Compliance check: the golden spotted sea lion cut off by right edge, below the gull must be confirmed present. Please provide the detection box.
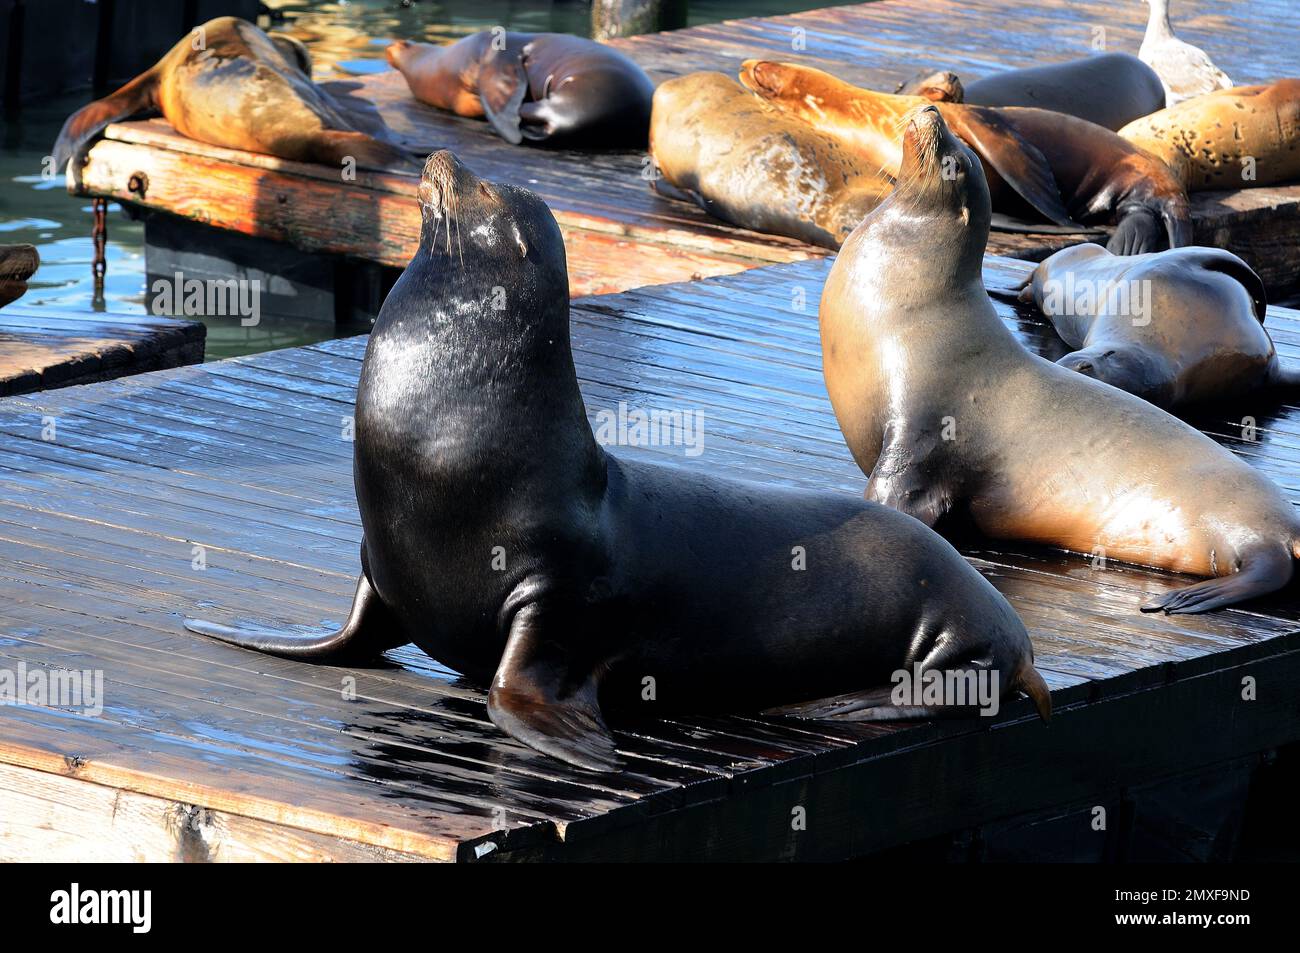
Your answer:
[1119,79,1300,192]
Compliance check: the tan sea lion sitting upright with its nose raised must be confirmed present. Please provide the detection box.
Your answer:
[820,104,1300,612]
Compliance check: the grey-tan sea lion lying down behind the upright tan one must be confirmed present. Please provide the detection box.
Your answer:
[1021,244,1300,408]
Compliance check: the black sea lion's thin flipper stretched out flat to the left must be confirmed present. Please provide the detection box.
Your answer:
[185,573,411,663]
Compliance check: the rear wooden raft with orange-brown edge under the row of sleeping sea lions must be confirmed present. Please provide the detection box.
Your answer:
[73,0,1300,295]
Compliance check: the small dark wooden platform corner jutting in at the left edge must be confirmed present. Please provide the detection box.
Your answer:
[0,302,207,395]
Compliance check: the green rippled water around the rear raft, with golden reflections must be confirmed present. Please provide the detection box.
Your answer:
[0,0,833,360]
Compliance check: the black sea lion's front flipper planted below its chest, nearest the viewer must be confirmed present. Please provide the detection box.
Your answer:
[488,603,619,771]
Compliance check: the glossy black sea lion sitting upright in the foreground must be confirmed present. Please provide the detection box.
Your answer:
[186,152,1050,770]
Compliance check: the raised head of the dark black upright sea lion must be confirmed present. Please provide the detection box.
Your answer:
[416,150,568,286]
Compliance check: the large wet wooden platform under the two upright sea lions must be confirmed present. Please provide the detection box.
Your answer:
[0,260,1300,861]
